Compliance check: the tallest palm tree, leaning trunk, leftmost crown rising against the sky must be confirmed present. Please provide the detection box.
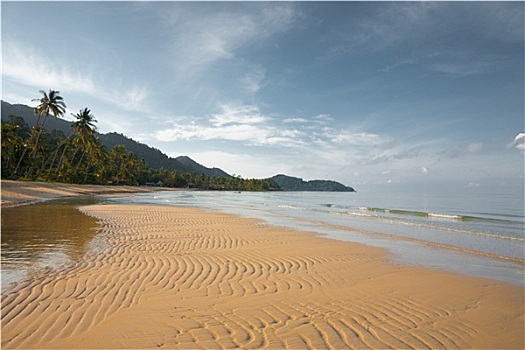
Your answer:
[15,90,66,177]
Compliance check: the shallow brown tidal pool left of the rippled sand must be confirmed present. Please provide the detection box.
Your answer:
[1,198,99,290]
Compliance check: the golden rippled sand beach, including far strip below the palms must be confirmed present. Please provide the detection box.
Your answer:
[2,181,525,349]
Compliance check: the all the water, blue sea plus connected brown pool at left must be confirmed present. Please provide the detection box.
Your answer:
[2,186,525,291]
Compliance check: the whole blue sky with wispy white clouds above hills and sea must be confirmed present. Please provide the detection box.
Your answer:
[1,1,525,189]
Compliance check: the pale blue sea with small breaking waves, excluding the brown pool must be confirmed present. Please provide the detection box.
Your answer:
[112,189,525,285]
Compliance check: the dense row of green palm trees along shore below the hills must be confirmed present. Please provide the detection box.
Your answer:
[1,90,279,191]
